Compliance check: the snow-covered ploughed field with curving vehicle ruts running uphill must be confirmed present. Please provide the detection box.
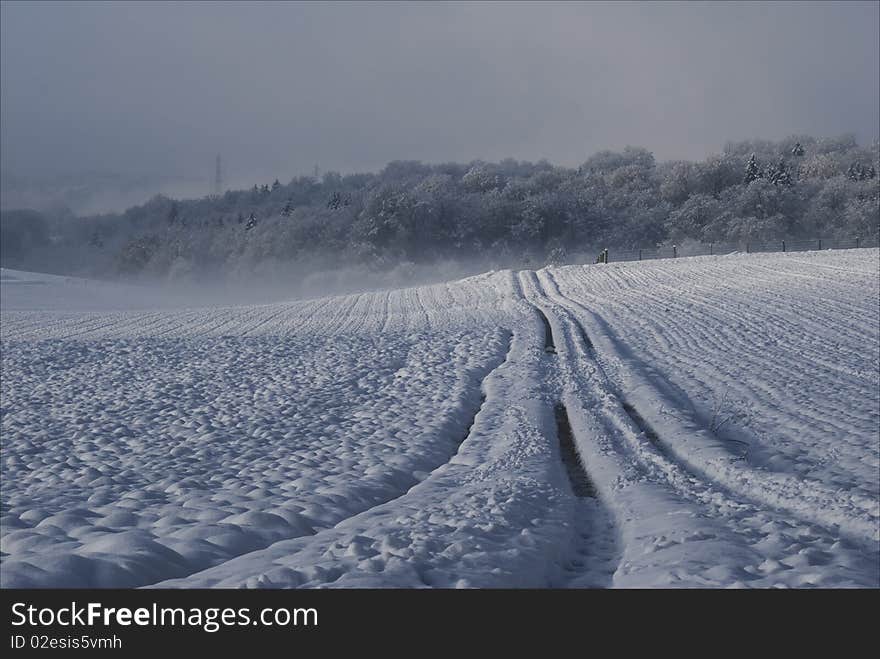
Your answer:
[0,249,880,587]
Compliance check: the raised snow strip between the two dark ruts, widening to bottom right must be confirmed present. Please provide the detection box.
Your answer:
[531,272,878,587]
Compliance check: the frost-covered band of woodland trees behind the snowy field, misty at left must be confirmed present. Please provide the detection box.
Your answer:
[0,135,880,278]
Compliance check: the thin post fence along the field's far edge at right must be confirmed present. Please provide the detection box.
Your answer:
[596,237,880,263]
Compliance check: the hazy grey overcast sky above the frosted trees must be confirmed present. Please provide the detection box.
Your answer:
[0,2,880,186]
